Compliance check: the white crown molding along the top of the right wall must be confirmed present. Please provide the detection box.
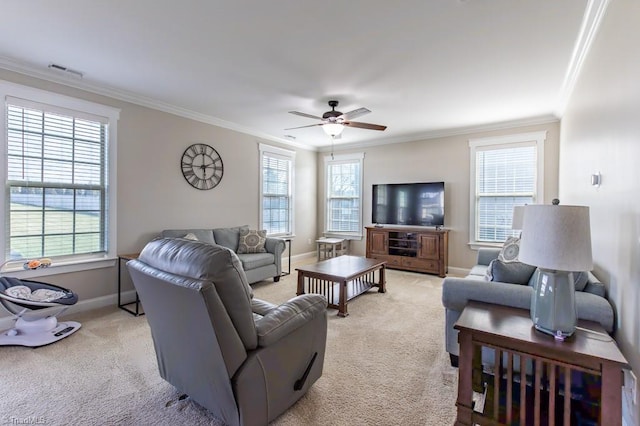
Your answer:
[555,0,610,117]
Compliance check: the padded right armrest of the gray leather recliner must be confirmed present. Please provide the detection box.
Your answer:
[256,294,327,347]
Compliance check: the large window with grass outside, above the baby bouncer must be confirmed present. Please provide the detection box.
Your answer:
[0,83,118,272]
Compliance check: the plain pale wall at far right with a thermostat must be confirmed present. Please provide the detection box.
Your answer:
[560,0,640,421]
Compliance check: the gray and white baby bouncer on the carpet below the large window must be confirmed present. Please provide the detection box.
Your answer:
[0,277,80,347]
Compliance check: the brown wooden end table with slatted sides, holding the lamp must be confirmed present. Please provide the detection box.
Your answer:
[455,302,628,426]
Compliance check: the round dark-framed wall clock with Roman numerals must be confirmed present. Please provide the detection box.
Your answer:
[182,143,224,190]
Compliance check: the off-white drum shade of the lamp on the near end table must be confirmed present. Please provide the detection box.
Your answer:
[518,204,593,271]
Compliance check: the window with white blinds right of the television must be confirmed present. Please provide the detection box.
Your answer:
[469,132,546,245]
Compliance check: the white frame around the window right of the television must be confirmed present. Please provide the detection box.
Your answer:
[469,131,547,250]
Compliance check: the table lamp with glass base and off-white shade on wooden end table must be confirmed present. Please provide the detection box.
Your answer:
[519,200,593,340]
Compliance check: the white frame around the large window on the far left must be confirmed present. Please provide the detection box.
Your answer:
[0,80,120,277]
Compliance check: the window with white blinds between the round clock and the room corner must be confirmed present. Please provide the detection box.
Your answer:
[259,144,295,236]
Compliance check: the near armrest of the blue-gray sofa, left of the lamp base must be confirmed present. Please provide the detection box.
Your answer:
[442,277,533,312]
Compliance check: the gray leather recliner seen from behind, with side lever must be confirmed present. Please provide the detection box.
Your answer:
[127,238,327,426]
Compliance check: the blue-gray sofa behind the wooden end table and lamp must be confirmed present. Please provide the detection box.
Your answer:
[442,248,614,366]
